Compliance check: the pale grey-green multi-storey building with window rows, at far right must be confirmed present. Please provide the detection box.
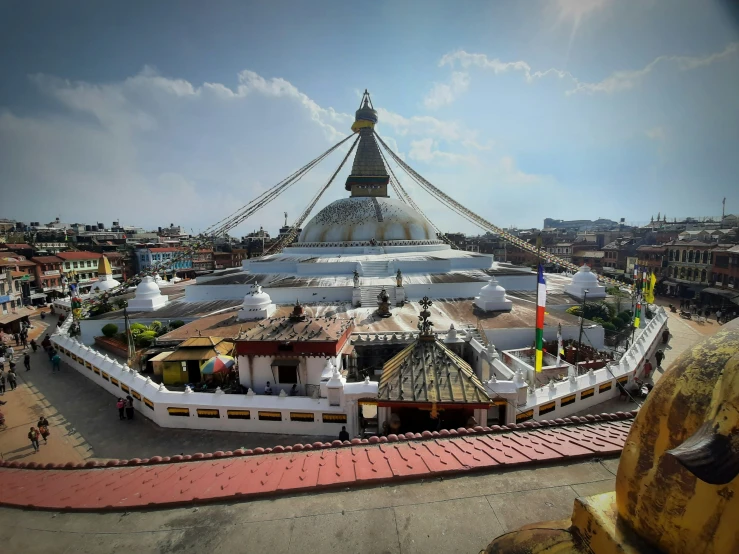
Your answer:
[664,240,714,296]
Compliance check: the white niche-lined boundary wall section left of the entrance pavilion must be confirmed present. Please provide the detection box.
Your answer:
[51,318,377,437]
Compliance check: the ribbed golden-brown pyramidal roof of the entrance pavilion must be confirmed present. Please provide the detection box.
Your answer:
[378,337,491,404]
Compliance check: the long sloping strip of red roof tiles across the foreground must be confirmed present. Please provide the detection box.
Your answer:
[0,413,634,511]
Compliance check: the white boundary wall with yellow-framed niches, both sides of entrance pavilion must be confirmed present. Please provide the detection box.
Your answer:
[51,307,667,436]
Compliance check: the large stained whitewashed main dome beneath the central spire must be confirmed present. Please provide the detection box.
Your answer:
[298,197,437,243]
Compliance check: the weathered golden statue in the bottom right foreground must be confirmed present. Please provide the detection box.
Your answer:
[484,320,739,554]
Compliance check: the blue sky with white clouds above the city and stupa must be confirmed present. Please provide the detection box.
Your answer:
[0,0,739,234]
